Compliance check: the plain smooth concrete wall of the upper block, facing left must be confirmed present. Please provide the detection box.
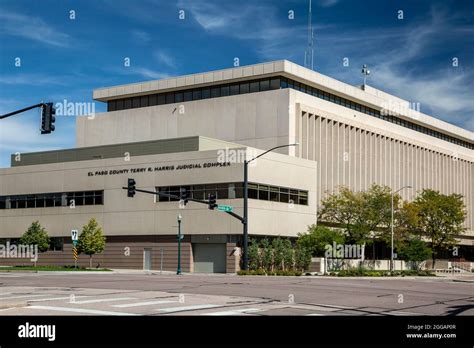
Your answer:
[76,89,289,153]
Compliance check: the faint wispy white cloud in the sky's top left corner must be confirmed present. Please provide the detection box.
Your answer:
[0,10,70,47]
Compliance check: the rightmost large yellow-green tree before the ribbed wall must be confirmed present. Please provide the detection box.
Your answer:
[413,189,466,268]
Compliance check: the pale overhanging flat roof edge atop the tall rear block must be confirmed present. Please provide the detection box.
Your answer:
[93,60,474,141]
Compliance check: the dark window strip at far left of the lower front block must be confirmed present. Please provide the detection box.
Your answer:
[0,191,104,209]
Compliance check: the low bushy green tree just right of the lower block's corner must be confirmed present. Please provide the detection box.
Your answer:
[296,225,344,257]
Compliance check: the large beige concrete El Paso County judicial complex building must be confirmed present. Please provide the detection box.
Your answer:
[0,60,474,272]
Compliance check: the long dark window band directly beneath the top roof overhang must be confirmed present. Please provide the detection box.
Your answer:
[107,77,474,149]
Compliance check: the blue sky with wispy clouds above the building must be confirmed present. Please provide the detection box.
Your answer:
[0,0,474,167]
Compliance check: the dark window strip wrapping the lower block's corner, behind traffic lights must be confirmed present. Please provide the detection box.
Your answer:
[156,182,308,205]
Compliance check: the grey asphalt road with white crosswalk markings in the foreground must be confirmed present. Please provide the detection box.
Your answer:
[0,272,474,315]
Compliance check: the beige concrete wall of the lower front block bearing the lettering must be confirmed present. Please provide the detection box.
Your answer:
[0,150,316,237]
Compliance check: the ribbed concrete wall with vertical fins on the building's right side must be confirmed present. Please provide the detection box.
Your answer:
[290,91,474,239]
